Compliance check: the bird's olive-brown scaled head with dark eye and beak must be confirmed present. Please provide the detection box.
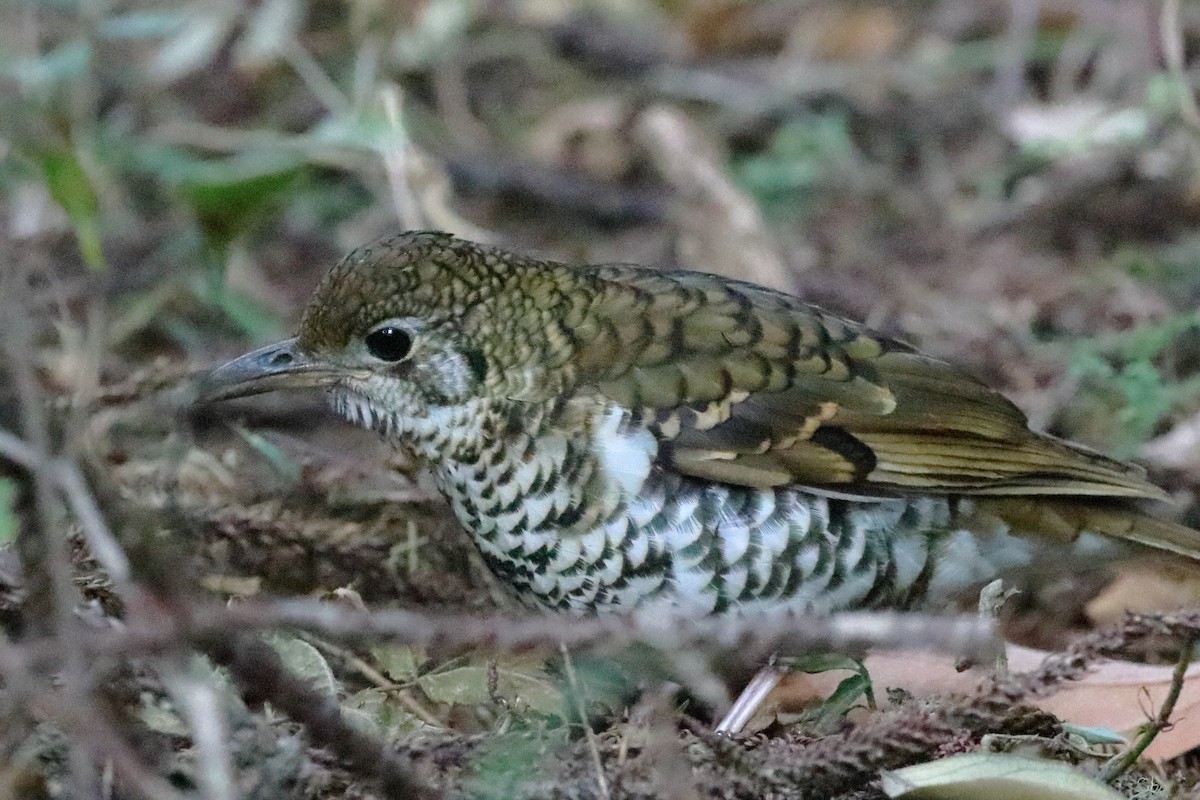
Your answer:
[198,233,577,450]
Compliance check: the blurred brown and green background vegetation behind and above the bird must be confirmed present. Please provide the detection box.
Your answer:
[7,0,1200,456]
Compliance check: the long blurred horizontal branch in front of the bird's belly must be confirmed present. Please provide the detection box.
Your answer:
[0,599,998,674]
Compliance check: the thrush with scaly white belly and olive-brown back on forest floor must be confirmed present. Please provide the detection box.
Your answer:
[197,231,1200,734]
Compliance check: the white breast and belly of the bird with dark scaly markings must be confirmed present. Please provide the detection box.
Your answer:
[438,402,984,613]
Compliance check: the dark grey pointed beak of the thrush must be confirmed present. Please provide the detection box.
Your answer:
[196,338,341,403]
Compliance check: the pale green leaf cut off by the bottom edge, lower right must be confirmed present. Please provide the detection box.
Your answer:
[882,753,1123,800]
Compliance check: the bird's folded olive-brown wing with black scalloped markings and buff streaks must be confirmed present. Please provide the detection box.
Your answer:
[563,265,1163,498]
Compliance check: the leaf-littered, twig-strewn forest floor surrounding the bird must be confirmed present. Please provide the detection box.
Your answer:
[7,0,1200,800]
